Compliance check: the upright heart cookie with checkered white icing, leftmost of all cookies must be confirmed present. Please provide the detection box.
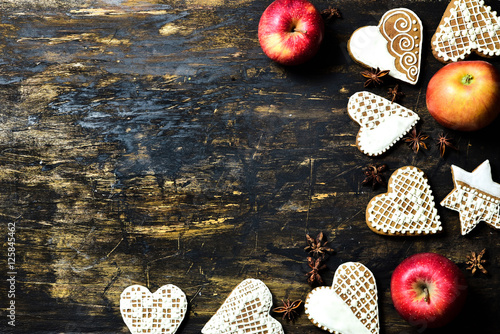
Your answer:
[120,284,187,334]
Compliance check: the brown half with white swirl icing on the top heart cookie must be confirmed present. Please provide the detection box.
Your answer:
[379,8,422,82]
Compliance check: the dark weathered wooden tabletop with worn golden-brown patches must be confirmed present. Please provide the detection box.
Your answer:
[0,0,500,334]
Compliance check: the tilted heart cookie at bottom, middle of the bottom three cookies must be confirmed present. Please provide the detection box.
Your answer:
[201,279,284,334]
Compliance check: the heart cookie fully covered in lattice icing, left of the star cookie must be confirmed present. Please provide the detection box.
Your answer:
[366,166,442,235]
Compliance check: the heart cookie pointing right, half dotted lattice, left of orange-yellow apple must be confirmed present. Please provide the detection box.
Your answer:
[347,91,419,156]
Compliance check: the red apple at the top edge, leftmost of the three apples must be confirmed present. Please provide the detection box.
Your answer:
[259,0,325,65]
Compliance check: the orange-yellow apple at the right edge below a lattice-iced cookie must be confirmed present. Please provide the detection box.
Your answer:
[426,60,500,131]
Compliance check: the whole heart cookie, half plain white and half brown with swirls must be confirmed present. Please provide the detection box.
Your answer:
[347,8,422,85]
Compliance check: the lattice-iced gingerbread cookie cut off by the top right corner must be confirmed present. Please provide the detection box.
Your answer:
[431,0,500,63]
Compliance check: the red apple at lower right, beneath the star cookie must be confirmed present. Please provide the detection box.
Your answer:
[391,253,467,329]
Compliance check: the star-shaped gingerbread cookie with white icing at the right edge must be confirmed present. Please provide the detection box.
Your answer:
[441,160,500,235]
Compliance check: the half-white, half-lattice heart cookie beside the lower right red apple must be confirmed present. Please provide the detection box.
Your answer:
[304,262,380,334]
